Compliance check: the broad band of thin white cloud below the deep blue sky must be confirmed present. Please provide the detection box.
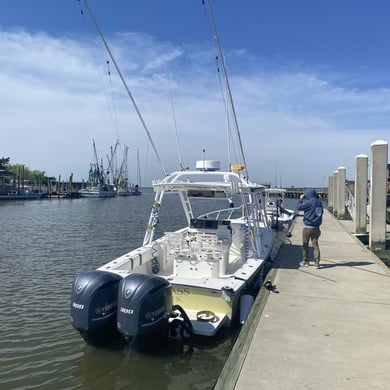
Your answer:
[0,31,390,186]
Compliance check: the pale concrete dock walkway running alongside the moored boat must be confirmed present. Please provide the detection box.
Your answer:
[214,210,390,390]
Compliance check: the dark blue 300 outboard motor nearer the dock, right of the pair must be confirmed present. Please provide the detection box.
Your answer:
[118,274,172,349]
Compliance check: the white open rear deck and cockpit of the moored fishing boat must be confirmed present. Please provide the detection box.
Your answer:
[99,227,265,289]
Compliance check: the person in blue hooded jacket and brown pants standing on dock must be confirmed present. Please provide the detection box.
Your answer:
[298,188,324,268]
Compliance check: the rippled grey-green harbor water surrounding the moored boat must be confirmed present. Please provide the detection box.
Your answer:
[0,190,296,390]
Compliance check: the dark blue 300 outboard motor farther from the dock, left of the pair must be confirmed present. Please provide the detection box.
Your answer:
[70,270,122,345]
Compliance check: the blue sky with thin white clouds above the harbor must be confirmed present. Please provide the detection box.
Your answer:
[0,0,390,187]
